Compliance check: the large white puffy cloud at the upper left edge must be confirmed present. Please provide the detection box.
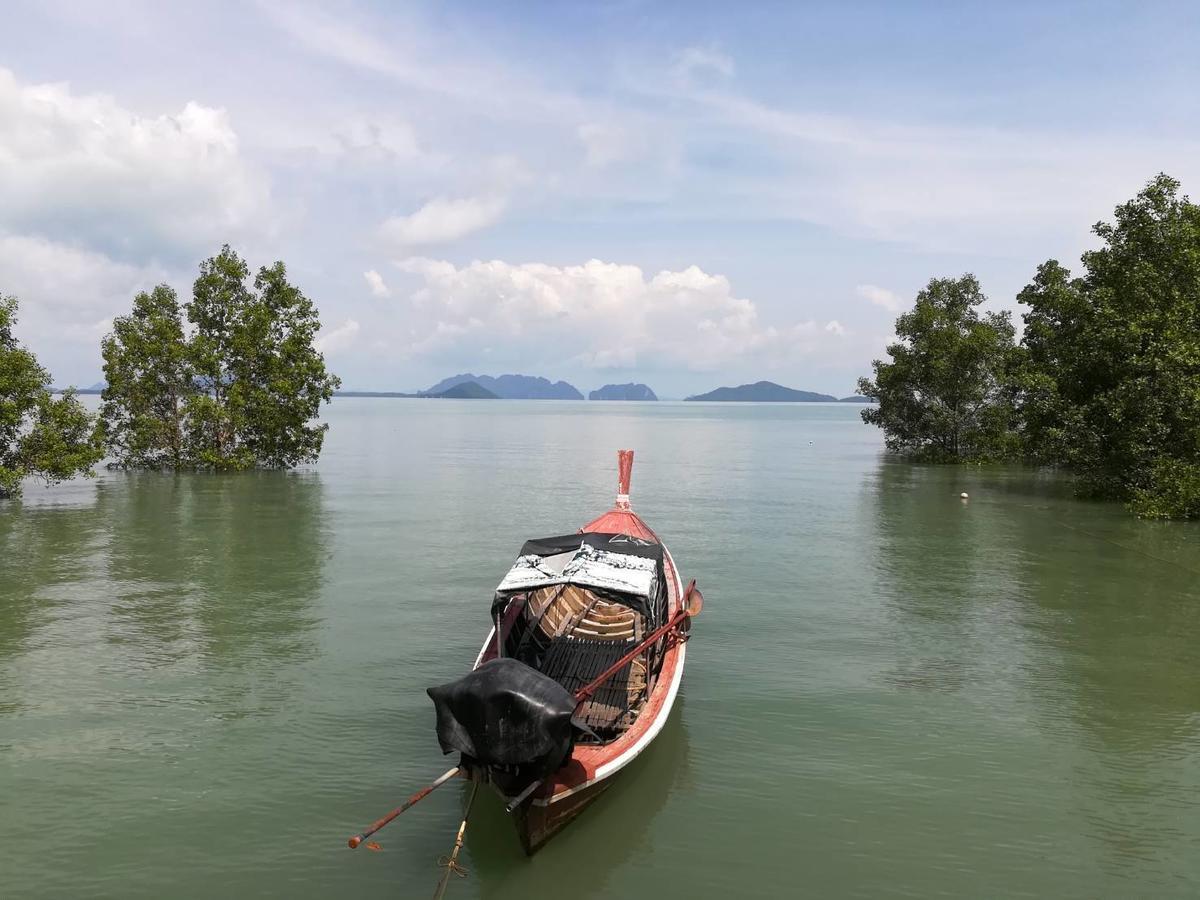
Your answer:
[0,68,266,253]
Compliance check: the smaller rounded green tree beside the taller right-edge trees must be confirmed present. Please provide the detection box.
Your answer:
[858,275,1016,462]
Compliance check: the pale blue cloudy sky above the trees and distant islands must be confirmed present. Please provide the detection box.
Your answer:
[0,0,1200,397]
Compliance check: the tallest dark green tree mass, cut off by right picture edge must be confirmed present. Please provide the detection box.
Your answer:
[1014,175,1200,516]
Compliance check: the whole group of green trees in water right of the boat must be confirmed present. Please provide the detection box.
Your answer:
[858,174,1200,518]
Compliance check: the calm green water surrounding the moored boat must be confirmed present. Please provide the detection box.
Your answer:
[0,400,1200,898]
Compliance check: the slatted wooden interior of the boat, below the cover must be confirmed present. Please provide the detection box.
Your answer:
[504,584,665,744]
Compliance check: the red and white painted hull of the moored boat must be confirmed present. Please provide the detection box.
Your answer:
[475,504,685,854]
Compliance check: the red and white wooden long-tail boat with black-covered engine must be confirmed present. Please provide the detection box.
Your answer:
[430,450,702,853]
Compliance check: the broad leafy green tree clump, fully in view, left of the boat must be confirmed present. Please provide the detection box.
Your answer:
[104,246,340,470]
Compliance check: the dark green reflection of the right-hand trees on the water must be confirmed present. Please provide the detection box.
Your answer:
[872,461,1200,751]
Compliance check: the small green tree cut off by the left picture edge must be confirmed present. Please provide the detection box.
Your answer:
[0,296,103,497]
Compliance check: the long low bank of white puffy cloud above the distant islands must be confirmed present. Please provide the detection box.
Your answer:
[388,258,829,370]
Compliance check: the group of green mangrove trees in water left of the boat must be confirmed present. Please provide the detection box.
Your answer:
[0,245,341,498]
